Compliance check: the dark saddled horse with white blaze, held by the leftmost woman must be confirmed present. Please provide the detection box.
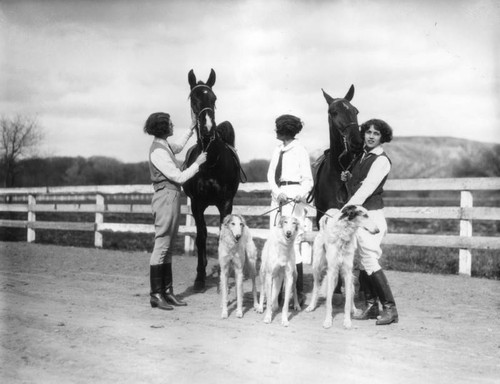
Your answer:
[183,69,240,292]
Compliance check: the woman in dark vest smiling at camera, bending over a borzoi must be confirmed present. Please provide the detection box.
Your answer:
[344,119,398,325]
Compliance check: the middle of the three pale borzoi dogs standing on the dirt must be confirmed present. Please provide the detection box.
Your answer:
[257,216,300,327]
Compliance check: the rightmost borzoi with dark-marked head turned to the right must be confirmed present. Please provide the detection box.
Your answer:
[306,205,379,328]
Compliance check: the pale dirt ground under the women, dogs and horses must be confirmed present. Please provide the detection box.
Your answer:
[0,242,500,384]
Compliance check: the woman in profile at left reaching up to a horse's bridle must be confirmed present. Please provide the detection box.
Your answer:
[144,112,207,310]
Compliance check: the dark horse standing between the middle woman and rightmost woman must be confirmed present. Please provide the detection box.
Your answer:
[312,85,363,225]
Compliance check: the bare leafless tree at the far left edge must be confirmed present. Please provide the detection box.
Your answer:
[0,115,43,188]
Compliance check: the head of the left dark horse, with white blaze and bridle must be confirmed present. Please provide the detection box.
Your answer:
[188,69,217,140]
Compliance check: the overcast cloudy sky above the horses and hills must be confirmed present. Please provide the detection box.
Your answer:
[0,0,500,162]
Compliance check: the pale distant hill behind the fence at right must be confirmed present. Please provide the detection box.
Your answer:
[312,136,500,179]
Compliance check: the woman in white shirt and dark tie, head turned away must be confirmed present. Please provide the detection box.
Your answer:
[267,115,313,306]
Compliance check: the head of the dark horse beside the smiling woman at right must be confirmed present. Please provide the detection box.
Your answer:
[321,85,363,153]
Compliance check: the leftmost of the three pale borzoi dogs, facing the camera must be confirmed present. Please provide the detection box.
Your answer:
[219,215,258,319]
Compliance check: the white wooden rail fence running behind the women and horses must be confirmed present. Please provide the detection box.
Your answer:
[0,178,500,276]
